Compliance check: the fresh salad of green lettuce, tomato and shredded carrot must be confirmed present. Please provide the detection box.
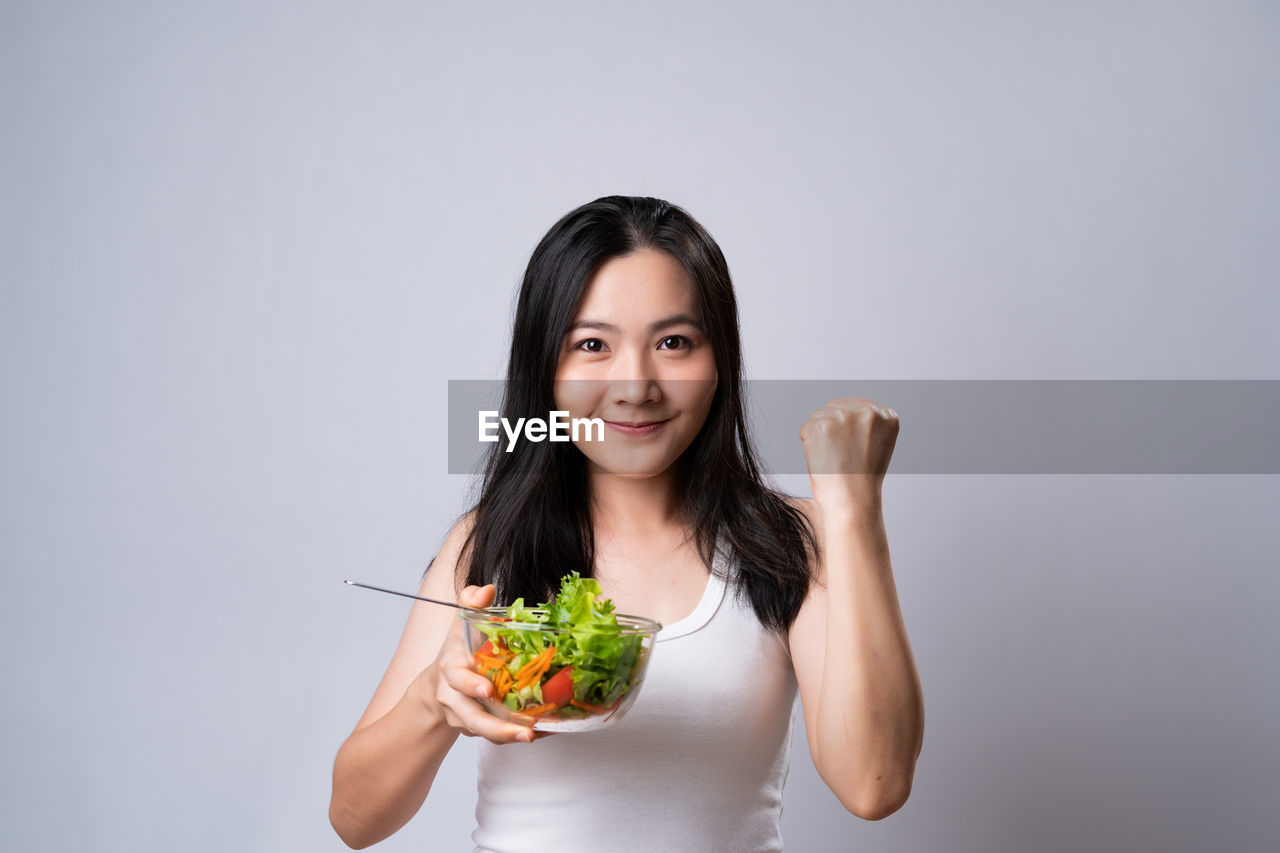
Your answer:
[472,571,644,719]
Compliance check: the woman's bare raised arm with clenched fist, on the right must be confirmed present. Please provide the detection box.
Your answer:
[788,397,924,820]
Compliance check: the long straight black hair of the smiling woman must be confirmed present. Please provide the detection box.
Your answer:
[462,196,817,631]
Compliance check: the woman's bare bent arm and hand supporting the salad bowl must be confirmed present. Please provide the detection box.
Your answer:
[329,515,534,849]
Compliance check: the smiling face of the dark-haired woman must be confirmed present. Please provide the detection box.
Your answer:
[556,248,717,478]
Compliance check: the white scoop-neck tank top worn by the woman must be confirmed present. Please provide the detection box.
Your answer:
[471,540,796,853]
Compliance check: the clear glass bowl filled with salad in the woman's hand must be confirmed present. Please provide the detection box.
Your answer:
[458,607,662,731]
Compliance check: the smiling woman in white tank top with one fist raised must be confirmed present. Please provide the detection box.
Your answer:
[329,196,924,853]
